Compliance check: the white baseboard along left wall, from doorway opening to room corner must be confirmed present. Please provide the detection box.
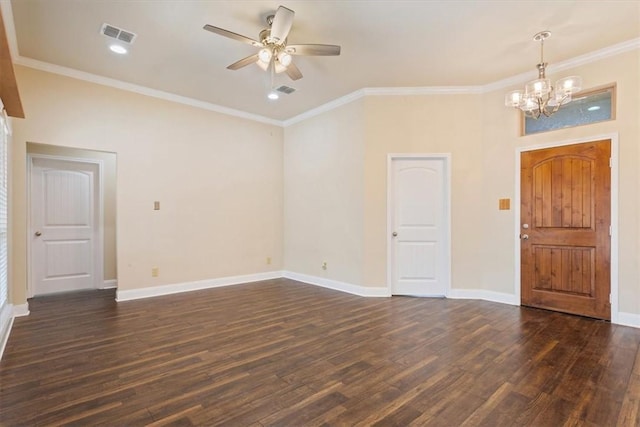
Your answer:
[116,271,282,302]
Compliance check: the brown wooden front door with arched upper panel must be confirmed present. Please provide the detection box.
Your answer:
[520,140,611,320]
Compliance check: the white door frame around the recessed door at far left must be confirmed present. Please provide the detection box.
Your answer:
[26,153,104,298]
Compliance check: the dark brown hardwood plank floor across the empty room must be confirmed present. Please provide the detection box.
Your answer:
[0,279,640,426]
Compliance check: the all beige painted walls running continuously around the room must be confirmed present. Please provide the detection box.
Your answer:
[11,50,640,314]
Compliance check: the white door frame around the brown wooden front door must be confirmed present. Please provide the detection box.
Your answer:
[513,132,619,323]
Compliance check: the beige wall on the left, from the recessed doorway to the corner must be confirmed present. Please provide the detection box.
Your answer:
[10,66,283,304]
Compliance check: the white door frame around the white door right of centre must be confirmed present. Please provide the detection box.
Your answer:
[387,153,451,297]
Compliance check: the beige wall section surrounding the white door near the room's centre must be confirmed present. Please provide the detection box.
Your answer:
[363,95,482,287]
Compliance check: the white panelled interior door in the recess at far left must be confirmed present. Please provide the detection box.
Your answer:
[30,157,102,296]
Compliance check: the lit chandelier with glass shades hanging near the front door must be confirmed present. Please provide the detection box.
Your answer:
[504,31,582,119]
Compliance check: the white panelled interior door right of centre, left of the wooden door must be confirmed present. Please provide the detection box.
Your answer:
[389,158,449,296]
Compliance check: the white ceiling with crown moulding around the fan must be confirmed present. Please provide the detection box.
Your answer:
[2,0,640,120]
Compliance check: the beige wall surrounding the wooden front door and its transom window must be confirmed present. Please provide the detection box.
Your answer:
[482,50,640,314]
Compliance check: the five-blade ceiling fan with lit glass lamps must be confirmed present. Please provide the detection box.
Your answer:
[204,6,340,80]
